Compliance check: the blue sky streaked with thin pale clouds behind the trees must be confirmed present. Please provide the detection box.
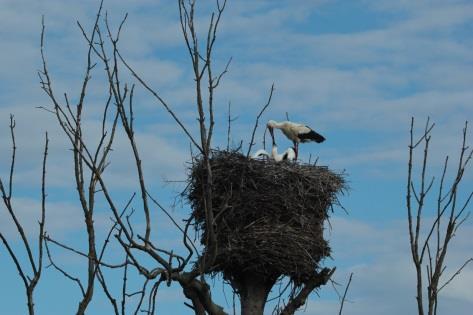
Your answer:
[0,0,473,315]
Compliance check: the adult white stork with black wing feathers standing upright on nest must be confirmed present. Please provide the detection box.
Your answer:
[266,120,325,159]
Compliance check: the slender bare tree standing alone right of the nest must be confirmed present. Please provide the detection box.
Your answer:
[406,118,473,315]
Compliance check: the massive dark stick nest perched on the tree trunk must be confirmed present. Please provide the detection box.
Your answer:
[187,151,345,283]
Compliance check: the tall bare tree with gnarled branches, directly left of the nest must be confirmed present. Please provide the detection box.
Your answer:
[35,1,230,314]
